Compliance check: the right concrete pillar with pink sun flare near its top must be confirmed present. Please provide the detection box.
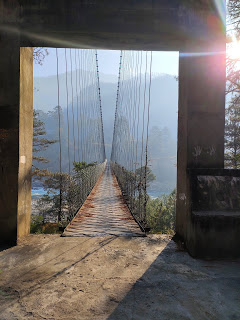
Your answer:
[176,42,226,245]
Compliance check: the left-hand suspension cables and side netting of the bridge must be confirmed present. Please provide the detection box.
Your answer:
[56,49,105,221]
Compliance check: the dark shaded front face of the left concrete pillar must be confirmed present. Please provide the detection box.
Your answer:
[0,40,20,243]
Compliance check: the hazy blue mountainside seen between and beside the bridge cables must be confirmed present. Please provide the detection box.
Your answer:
[34,74,178,194]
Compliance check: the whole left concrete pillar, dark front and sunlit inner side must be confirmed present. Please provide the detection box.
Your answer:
[0,29,33,244]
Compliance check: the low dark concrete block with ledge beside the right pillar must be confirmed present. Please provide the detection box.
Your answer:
[187,169,240,258]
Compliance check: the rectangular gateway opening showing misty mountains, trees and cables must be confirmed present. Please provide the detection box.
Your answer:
[31,48,179,235]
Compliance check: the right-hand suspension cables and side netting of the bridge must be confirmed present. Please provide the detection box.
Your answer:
[110,51,152,229]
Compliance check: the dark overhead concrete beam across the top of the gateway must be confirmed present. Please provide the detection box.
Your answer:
[2,0,222,51]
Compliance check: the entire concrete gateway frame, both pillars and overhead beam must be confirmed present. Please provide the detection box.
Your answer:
[0,0,233,255]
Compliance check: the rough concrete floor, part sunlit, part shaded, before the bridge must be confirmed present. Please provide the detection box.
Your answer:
[0,235,240,320]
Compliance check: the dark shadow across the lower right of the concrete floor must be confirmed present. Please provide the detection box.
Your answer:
[107,241,240,320]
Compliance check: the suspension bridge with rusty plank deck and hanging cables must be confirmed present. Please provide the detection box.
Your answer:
[44,49,152,236]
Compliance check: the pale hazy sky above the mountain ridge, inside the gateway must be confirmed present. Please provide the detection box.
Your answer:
[34,48,178,78]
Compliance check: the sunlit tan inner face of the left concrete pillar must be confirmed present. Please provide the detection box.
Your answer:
[17,48,33,239]
